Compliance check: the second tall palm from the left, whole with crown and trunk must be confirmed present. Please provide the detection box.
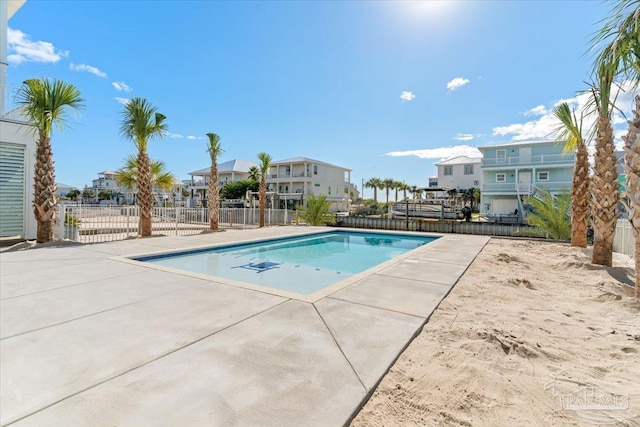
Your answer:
[120,97,167,237]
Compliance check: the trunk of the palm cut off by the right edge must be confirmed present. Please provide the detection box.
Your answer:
[623,96,640,298]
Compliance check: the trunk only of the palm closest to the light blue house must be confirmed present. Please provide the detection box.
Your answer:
[571,144,589,248]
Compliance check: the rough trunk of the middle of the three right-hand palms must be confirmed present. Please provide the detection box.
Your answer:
[591,117,618,267]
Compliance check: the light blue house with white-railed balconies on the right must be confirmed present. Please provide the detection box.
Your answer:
[479,141,575,220]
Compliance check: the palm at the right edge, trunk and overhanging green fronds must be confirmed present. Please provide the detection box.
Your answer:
[592,0,640,298]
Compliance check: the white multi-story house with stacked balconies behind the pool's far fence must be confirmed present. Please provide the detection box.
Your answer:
[267,157,357,211]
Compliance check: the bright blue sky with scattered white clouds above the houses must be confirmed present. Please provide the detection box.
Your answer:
[7,0,631,197]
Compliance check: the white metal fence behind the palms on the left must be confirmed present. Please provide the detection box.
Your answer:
[55,205,295,243]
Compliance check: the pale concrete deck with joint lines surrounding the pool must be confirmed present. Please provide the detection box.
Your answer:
[0,226,489,426]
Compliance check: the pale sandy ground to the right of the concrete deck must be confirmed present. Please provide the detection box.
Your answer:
[352,239,640,426]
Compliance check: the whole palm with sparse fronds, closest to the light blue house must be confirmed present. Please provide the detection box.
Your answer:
[553,102,589,248]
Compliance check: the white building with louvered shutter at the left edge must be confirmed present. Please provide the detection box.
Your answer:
[0,0,36,239]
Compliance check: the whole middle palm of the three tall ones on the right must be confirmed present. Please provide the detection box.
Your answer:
[591,63,618,267]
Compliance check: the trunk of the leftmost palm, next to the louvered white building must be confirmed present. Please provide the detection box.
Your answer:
[33,132,56,243]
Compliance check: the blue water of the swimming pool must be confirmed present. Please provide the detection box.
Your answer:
[136,231,437,295]
